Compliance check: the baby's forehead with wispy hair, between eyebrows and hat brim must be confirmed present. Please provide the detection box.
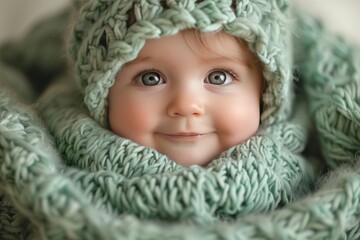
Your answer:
[125,29,260,69]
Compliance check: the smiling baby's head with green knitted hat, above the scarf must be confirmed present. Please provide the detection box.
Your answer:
[70,0,291,167]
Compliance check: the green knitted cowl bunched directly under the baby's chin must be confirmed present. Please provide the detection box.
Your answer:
[35,82,313,223]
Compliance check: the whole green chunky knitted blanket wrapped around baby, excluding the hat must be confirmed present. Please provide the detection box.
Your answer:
[0,7,360,239]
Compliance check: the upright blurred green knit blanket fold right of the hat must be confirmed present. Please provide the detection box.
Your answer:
[295,12,360,168]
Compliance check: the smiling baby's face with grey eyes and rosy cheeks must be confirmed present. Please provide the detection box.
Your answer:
[108,30,262,166]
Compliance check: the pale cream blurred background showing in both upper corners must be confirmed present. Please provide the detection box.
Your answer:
[0,0,360,45]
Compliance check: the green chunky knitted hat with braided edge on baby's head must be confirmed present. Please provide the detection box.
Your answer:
[70,0,291,126]
